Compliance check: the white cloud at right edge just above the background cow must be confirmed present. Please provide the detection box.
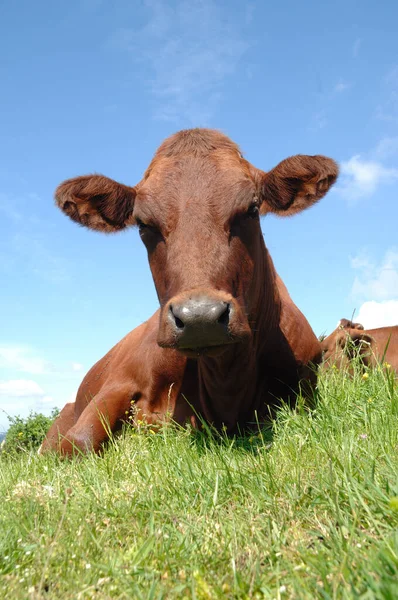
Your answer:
[351,248,398,302]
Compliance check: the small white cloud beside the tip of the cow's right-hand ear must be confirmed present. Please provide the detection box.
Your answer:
[336,154,398,202]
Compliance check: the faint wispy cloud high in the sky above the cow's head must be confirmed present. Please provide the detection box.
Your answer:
[109,0,249,125]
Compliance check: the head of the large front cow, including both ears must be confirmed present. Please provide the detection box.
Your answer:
[56,129,338,356]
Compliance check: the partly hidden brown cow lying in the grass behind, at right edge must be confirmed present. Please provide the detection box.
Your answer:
[321,319,398,373]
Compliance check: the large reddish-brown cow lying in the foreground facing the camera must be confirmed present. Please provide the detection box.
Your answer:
[43,129,338,454]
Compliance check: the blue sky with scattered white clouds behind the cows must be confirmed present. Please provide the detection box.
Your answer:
[0,0,398,431]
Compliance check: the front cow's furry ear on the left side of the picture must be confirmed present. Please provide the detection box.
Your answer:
[55,175,136,233]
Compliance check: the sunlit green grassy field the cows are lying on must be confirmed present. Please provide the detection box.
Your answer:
[0,370,398,600]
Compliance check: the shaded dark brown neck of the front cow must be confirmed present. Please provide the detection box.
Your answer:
[197,240,280,431]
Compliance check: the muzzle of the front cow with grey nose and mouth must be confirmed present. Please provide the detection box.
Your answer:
[158,292,247,357]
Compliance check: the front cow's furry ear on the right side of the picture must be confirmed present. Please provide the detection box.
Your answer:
[260,154,339,217]
